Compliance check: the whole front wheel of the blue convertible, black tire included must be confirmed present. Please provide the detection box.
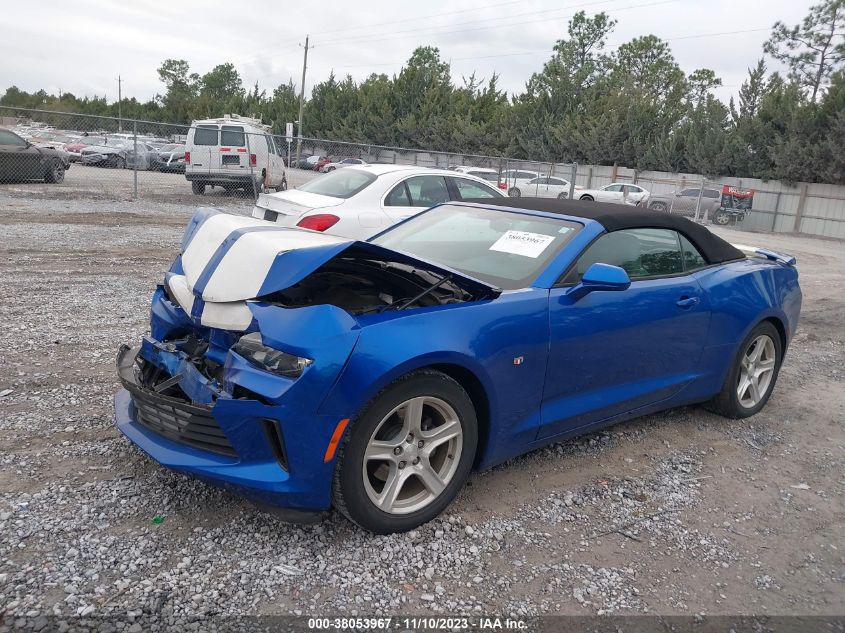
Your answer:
[332,370,478,534]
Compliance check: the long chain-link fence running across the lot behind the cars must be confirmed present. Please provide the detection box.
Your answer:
[0,106,845,238]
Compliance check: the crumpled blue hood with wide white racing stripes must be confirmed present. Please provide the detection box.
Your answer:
[176,208,499,302]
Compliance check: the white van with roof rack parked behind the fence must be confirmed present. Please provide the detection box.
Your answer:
[185,114,287,195]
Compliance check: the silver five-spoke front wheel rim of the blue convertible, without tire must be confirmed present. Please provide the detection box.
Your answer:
[362,396,463,514]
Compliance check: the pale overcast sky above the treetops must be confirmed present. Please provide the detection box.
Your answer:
[0,0,812,107]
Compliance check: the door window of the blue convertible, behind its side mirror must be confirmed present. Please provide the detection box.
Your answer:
[575,229,684,279]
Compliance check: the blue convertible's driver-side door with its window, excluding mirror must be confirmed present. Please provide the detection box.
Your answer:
[540,229,710,437]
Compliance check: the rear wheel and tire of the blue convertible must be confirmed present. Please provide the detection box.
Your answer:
[704,321,783,419]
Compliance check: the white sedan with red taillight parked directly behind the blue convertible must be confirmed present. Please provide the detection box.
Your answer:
[252,165,504,240]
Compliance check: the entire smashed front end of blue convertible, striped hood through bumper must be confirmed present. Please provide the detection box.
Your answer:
[115,210,498,519]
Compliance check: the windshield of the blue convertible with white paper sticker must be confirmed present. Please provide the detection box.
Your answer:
[372,204,581,290]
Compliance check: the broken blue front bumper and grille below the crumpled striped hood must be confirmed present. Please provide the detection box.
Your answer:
[114,287,357,522]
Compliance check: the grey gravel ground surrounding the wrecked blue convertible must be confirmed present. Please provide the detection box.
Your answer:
[0,194,845,631]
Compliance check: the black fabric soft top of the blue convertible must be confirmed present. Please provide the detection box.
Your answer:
[462,198,745,264]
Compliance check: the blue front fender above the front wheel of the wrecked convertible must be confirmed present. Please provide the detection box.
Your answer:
[319,288,549,461]
